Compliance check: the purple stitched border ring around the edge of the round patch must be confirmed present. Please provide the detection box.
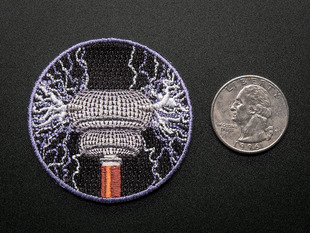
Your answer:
[28,38,193,203]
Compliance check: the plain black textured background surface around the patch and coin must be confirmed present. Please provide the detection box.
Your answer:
[0,0,310,232]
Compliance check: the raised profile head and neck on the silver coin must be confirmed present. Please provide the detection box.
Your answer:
[230,84,273,143]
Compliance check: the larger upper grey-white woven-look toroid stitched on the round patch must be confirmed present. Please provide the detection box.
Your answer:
[67,90,153,131]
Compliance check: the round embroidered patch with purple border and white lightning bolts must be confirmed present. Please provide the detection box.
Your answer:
[29,39,192,202]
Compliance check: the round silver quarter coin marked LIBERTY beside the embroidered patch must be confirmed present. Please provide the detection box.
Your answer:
[211,75,289,153]
